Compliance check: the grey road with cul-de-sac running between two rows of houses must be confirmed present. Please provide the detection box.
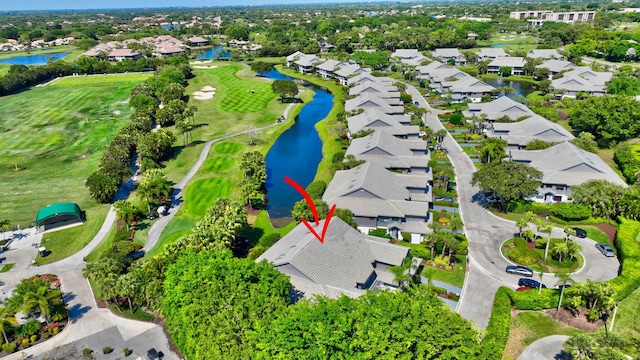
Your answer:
[407,86,620,329]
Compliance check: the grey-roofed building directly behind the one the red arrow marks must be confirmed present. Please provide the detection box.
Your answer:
[322,162,432,243]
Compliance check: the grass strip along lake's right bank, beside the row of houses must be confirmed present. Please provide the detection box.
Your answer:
[276,65,345,183]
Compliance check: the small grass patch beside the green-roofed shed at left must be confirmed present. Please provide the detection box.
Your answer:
[36,205,109,265]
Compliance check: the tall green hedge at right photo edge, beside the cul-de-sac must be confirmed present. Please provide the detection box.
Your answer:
[609,218,640,300]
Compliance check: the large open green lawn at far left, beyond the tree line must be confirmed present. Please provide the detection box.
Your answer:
[0,74,149,225]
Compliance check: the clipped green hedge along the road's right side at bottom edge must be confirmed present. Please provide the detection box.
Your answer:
[477,286,513,360]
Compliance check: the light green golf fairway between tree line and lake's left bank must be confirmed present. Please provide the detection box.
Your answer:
[146,63,313,256]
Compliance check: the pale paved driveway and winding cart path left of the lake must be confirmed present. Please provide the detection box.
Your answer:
[0,98,294,360]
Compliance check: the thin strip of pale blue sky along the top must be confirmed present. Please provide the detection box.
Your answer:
[0,0,376,11]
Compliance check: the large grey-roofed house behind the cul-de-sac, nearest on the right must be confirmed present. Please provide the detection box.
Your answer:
[508,142,627,203]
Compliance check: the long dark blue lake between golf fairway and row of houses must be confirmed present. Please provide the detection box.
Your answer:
[260,69,333,219]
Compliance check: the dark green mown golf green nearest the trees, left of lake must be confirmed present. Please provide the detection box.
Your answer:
[184,178,231,217]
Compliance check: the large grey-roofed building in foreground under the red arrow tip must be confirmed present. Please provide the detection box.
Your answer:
[256,216,417,300]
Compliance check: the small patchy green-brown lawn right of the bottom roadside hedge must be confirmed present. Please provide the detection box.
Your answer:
[503,311,582,359]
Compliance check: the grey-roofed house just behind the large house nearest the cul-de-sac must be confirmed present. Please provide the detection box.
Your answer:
[486,115,575,150]
